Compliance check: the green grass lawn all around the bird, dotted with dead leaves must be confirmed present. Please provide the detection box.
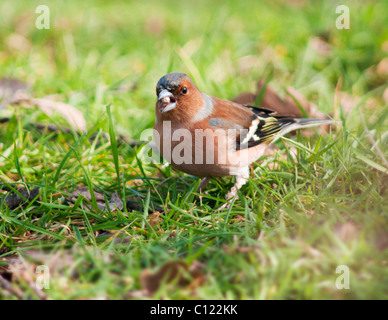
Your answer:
[0,0,388,299]
